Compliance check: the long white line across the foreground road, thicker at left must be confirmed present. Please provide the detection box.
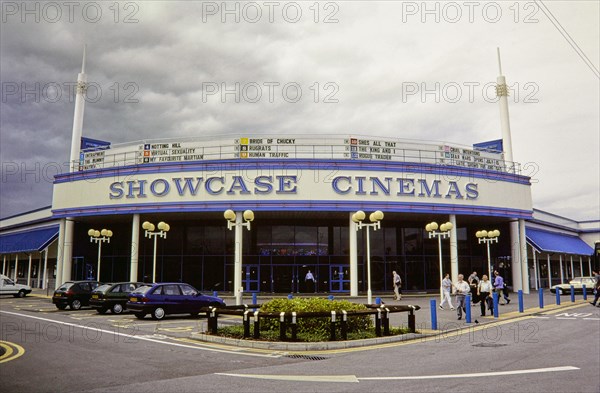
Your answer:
[215,366,579,383]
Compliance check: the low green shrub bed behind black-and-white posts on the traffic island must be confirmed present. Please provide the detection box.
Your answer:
[260,298,373,341]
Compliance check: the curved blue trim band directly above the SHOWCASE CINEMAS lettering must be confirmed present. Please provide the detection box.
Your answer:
[54,159,531,185]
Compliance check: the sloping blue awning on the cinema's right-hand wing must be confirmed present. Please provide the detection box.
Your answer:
[525,228,594,255]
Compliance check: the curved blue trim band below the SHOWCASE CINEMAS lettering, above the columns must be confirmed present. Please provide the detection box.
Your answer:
[52,200,533,219]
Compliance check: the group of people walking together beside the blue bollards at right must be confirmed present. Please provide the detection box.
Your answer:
[440,271,510,320]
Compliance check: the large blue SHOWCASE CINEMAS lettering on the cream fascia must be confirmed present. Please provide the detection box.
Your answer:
[109,175,479,200]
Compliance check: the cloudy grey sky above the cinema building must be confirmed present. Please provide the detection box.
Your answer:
[0,1,600,220]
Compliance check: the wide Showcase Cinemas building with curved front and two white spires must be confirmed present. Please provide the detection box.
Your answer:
[0,59,600,297]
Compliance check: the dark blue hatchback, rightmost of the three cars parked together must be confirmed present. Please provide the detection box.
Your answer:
[126,283,225,319]
